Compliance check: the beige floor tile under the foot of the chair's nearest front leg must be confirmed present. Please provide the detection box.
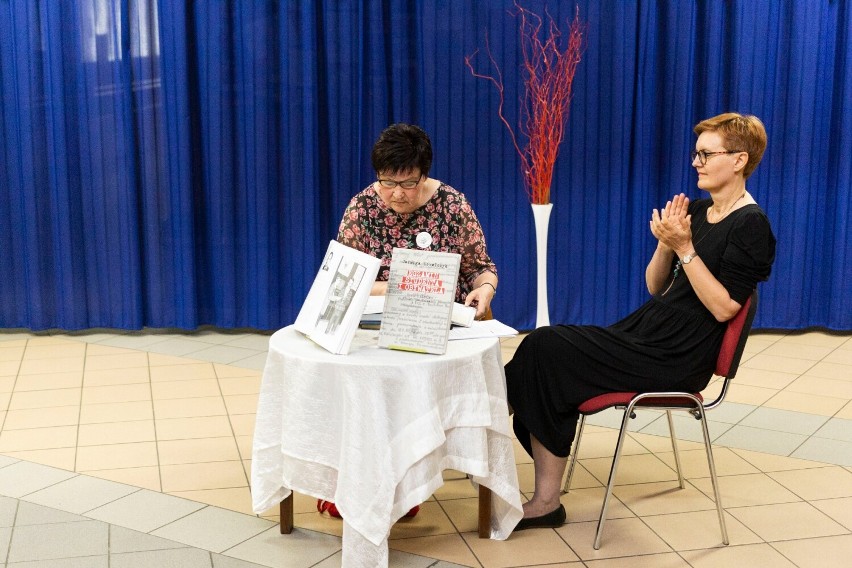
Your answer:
[560,518,672,561]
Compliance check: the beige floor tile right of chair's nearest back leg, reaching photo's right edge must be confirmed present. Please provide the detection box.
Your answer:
[728,503,848,542]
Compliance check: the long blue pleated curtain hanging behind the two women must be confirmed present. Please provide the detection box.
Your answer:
[0,0,852,330]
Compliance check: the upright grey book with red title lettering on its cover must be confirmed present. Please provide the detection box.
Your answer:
[379,248,461,355]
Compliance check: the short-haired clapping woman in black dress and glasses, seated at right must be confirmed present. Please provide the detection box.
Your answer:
[506,113,775,530]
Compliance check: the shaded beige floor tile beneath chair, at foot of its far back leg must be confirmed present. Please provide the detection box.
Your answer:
[613,481,716,517]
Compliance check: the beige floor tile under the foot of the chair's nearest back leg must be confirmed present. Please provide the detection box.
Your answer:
[643,509,761,550]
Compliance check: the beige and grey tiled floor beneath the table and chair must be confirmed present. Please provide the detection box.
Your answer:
[0,330,852,568]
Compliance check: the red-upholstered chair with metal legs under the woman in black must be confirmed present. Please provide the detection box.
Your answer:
[563,290,757,550]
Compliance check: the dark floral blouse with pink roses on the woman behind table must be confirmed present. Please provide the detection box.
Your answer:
[337,183,497,302]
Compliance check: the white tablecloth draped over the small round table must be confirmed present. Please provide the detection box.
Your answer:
[252,327,523,568]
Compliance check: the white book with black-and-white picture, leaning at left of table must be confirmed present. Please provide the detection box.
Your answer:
[293,241,381,354]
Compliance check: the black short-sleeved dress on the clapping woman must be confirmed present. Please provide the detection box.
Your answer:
[506,199,775,456]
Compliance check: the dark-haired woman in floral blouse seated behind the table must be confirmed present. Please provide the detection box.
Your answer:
[337,123,497,318]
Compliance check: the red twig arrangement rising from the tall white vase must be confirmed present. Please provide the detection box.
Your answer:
[464,2,585,204]
